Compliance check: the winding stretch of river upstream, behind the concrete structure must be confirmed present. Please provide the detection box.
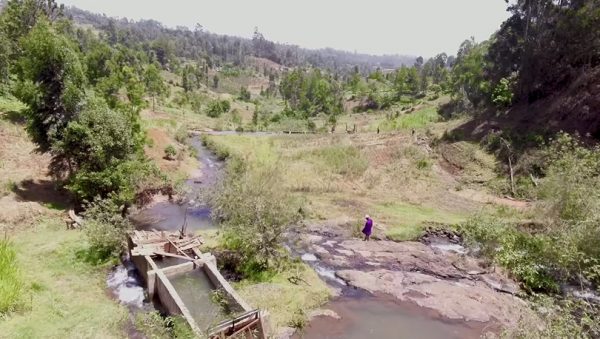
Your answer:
[131,137,223,233]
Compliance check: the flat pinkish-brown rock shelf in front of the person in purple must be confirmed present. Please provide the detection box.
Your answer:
[290,221,528,334]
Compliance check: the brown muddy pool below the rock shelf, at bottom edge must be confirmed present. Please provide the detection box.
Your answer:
[294,295,482,339]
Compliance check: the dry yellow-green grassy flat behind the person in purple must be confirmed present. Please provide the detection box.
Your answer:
[205,132,483,240]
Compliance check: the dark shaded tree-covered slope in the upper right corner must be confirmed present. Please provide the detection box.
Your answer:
[453,0,600,139]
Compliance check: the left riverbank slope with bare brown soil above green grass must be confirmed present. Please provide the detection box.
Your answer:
[0,97,128,339]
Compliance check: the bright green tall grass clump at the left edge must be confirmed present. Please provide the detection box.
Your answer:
[0,239,23,315]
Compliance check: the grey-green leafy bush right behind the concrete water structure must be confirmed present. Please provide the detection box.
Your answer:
[211,157,299,273]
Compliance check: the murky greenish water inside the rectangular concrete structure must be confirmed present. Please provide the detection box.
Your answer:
[169,269,227,329]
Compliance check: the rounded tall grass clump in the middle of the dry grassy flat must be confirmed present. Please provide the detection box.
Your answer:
[311,146,369,177]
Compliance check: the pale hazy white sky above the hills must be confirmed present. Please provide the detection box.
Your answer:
[59,0,508,57]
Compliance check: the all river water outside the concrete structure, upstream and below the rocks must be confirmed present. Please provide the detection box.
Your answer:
[108,136,502,339]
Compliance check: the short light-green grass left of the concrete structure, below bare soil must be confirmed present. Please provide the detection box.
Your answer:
[0,218,127,338]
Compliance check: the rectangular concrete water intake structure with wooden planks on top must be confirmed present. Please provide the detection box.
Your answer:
[127,230,267,339]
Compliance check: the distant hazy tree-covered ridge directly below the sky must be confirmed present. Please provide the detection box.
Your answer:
[65,7,415,73]
